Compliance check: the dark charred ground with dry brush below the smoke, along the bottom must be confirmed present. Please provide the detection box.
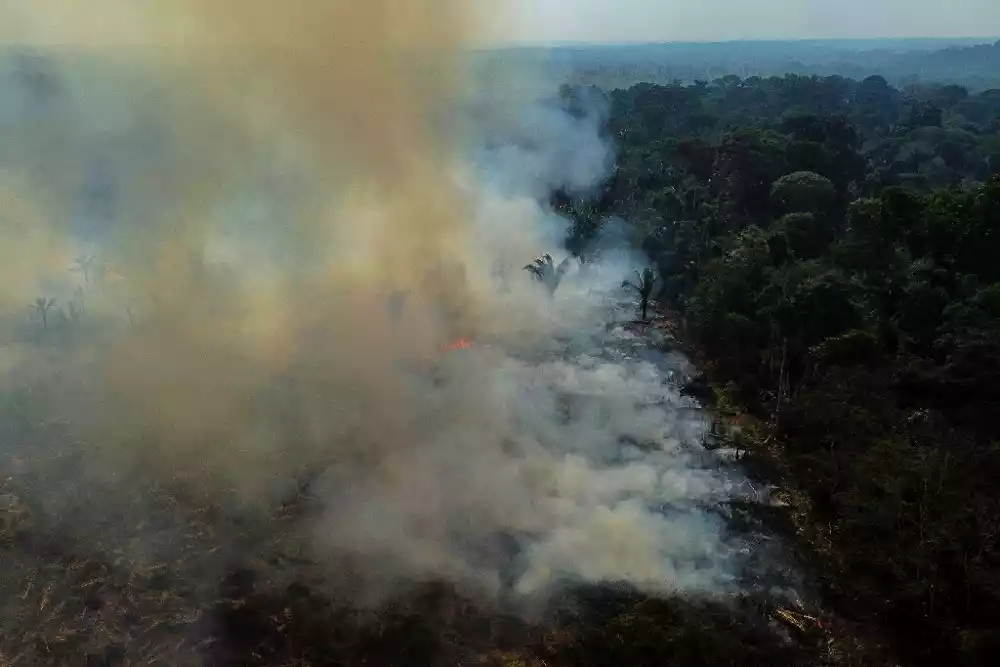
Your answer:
[0,454,830,667]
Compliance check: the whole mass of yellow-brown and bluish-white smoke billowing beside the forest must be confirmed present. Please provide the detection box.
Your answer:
[0,0,739,612]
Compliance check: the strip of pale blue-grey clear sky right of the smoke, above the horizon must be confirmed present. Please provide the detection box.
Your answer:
[493,0,1000,42]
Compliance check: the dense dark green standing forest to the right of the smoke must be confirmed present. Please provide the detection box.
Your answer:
[553,70,1000,665]
